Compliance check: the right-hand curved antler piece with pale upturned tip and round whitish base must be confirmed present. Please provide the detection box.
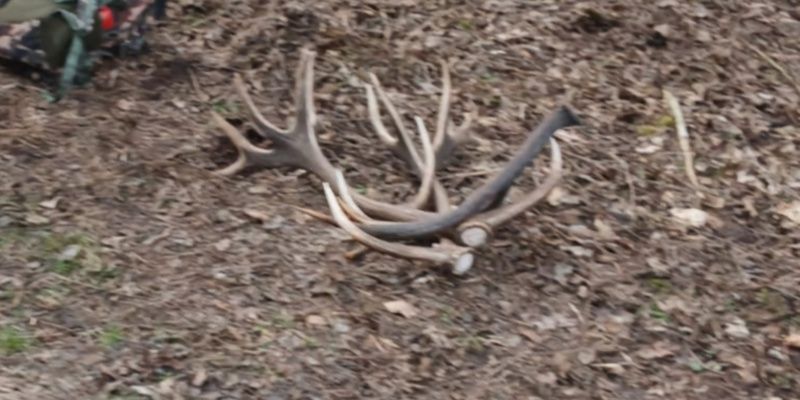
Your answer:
[458,138,563,248]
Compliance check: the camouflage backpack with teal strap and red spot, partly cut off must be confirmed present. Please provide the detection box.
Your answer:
[0,0,166,101]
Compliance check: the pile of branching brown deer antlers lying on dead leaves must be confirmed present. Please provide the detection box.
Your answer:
[212,50,580,274]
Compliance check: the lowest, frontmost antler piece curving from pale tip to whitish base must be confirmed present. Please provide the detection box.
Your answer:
[322,176,475,274]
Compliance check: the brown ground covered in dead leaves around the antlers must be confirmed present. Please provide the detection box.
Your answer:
[0,0,800,400]
